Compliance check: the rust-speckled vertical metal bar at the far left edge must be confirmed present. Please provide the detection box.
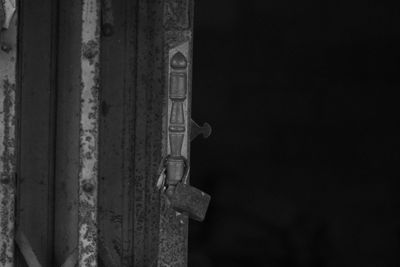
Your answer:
[0,8,17,267]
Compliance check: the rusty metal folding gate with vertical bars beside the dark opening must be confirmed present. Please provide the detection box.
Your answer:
[0,0,207,267]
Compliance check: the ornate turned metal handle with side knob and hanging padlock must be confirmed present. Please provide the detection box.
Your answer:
[161,45,211,221]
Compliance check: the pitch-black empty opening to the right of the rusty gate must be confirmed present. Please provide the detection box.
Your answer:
[189,0,400,267]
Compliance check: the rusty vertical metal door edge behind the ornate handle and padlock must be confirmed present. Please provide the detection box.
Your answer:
[158,0,193,267]
